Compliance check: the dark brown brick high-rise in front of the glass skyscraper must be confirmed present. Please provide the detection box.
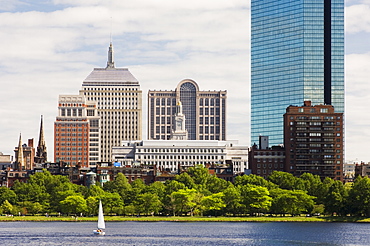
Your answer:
[284,101,344,180]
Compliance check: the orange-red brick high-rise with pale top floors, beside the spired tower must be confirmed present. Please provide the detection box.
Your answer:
[54,95,100,167]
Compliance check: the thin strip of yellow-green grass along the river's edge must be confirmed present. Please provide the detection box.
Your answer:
[0,216,370,222]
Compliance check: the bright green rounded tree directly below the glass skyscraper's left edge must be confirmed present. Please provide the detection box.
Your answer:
[240,185,272,214]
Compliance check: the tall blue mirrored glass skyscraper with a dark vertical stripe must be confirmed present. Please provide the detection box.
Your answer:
[251,0,344,145]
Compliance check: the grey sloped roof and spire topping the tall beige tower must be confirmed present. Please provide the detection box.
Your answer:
[82,43,139,86]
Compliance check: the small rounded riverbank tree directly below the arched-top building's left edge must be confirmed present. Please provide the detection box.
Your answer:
[134,193,162,215]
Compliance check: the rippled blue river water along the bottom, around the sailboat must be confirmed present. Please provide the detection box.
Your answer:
[0,222,370,246]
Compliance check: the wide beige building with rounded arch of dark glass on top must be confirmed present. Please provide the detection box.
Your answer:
[148,79,227,140]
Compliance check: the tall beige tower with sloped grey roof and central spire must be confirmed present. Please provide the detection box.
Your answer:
[80,43,142,162]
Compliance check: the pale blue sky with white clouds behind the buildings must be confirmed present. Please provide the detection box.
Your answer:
[0,0,370,162]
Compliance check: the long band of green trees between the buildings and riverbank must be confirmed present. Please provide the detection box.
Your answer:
[0,165,370,217]
